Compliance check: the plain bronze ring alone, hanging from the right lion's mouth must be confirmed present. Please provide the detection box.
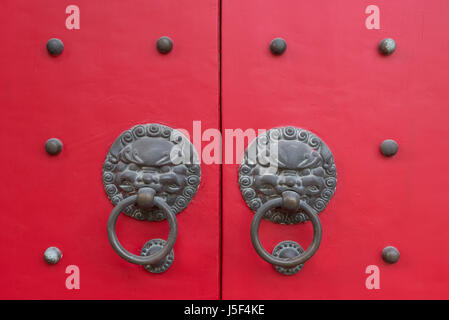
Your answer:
[251,198,322,268]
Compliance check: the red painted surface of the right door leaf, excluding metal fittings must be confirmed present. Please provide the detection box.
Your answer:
[222,0,449,299]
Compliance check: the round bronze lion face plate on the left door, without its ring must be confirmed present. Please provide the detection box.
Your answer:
[103,123,201,221]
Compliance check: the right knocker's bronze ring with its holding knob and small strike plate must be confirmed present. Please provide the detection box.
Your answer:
[251,191,322,274]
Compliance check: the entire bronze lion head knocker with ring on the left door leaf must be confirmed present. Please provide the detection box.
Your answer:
[103,123,201,273]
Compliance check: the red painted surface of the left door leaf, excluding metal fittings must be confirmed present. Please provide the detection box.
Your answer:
[0,0,220,299]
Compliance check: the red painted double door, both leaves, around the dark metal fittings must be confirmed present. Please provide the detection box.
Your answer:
[0,0,449,299]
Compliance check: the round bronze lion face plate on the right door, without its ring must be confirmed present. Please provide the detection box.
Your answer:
[239,127,337,224]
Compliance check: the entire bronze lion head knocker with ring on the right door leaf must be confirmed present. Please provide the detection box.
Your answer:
[239,127,337,275]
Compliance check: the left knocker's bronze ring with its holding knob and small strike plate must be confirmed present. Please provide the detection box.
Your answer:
[107,187,178,273]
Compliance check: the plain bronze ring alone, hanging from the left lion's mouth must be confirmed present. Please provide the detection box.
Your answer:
[108,195,178,265]
